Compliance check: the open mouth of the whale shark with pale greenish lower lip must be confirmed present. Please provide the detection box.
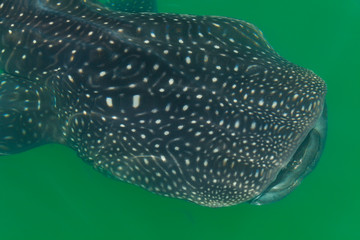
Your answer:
[249,104,327,205]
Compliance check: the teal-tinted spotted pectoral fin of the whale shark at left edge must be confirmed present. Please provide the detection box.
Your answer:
[0,73,58,155]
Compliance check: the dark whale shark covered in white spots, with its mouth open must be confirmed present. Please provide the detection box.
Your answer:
[0,0,327,207]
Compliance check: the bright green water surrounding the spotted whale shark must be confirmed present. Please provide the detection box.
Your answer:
[0,0,360,240]
